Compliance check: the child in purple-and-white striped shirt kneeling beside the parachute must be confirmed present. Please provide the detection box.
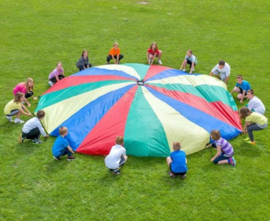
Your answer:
[207,130,236,166]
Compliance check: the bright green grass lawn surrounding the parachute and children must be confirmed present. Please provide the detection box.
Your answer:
[0,0,270,221]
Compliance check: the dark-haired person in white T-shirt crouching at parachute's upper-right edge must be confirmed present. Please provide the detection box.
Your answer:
[210,60,231,84]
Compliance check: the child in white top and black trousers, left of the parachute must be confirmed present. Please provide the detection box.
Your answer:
[19,110,49,144]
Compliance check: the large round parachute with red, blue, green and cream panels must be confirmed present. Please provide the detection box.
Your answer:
[35,64,242,157]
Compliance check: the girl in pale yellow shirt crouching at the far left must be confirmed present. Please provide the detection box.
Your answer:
[4,92,32,124]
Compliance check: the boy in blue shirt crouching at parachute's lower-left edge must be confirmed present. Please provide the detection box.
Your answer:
[52,127,75,161]
